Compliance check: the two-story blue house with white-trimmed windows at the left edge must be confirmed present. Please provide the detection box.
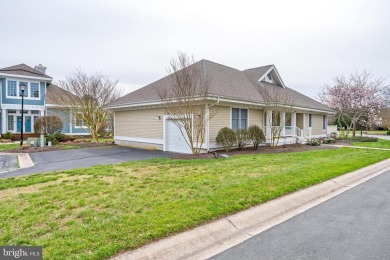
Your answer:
[0,64,88,135]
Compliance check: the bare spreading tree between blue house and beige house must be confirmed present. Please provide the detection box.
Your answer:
[55,69,121,142]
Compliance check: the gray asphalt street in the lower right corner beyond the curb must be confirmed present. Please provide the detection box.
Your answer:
[212,172,390,260]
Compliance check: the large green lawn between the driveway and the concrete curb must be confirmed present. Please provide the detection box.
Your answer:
[0,148,390,259]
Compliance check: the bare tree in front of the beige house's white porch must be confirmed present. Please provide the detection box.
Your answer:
[259,83,293,148]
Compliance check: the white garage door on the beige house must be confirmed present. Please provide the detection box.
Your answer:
[165,119,192,153]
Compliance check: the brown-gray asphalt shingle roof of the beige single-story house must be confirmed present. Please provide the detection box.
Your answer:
[107,60,333,112]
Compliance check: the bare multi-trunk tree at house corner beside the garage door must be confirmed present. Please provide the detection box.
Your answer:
[158,52,212,154]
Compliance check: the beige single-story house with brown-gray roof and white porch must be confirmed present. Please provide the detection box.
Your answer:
[106,60,334,153]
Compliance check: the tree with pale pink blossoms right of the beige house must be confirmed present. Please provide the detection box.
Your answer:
[319,71,388,137]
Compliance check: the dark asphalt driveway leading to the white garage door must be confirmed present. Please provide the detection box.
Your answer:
[0,145,173,178]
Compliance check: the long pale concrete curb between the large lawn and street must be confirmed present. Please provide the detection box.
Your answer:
[112,159,390,260]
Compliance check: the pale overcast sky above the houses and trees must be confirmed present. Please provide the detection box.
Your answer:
[0,0,390,97]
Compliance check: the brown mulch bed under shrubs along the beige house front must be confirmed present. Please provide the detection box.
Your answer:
[173,140,350,160]
